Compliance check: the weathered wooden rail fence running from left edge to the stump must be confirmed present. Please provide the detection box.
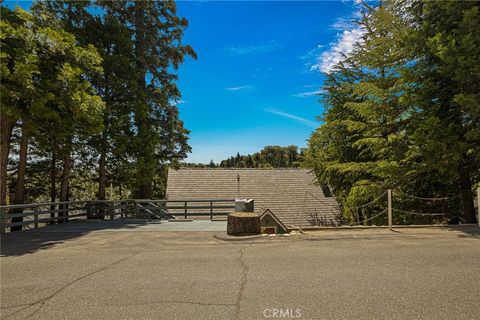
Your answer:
[0,199,235,233]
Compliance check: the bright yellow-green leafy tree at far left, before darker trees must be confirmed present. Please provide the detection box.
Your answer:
[1,7,103,226]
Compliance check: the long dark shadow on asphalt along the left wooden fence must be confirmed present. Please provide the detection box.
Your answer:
[0,219,154,257]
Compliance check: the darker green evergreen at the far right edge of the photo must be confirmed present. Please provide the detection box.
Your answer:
[406,1,480,222]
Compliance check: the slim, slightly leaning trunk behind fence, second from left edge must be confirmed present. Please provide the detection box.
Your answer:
[10,122,28,231]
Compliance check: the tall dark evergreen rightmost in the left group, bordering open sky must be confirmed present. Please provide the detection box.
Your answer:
[101,1,195,198]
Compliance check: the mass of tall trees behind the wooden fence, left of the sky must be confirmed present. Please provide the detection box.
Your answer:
[0,0,196,210]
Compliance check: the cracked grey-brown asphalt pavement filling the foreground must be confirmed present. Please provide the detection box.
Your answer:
[0,222,480,320]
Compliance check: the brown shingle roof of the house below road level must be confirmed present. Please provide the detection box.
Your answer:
[167,168,340,226]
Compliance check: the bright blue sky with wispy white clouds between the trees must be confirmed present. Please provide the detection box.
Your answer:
[7,1,361,163]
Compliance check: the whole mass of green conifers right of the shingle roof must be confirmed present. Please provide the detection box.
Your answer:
[305,1,480,222]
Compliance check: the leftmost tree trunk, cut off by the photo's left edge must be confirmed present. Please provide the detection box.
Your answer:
[0,115,15,205]
